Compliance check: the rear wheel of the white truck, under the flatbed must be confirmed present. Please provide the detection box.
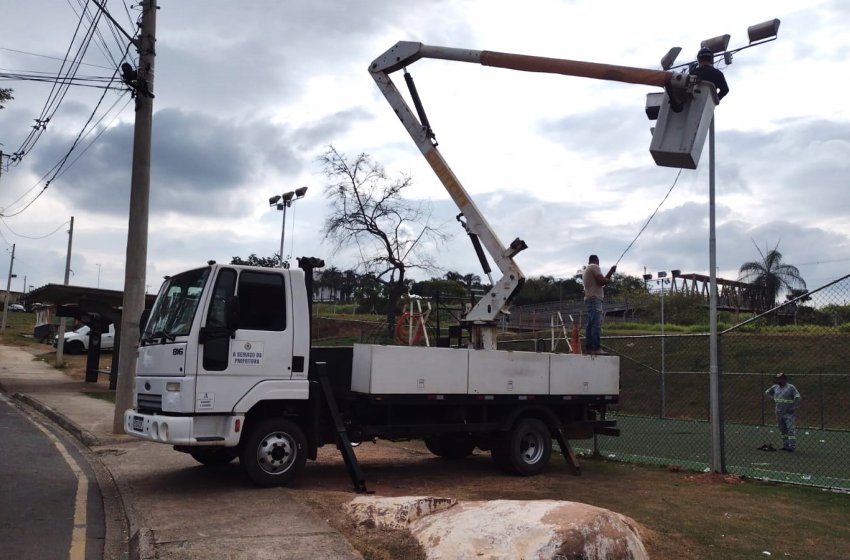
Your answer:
[491,418,552,476]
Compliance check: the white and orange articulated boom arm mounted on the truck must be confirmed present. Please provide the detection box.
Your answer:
[369,41,686,349]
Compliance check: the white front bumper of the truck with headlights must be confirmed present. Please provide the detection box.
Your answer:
[124,409,245,447]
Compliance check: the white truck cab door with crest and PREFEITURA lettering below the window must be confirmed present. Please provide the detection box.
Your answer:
[195,268,294,412]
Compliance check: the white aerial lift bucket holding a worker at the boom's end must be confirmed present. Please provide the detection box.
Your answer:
[649,82,719,169]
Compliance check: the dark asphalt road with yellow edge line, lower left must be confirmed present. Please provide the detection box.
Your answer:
[0,395,105,560]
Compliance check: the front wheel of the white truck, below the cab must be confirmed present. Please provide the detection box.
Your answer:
[239,418,307,487]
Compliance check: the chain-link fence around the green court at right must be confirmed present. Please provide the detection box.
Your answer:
[587,277,850,489]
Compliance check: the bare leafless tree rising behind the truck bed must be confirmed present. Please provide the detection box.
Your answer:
[319,146,447,335]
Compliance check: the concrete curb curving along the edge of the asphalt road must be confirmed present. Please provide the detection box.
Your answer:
[8,394,156,560]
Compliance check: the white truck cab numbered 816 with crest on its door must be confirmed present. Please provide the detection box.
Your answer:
[125,264,310,450]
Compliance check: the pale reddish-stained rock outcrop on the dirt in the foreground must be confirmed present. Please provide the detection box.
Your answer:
[349,497,649,560]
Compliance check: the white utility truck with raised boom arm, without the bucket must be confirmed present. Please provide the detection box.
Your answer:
[124,42,708,491]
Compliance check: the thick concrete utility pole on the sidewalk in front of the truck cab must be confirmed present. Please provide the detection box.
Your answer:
[112,0,158,434]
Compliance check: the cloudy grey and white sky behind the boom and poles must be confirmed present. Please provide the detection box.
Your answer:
[0,0,850,300]
